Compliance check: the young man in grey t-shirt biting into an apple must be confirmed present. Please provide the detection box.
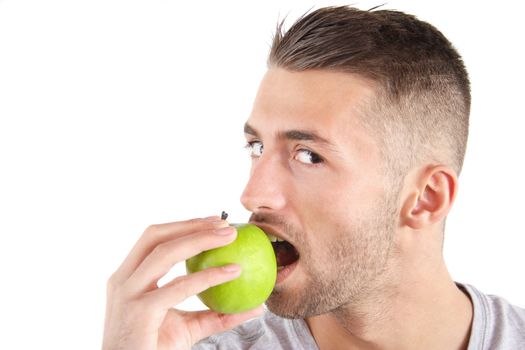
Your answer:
[104,7,525,350]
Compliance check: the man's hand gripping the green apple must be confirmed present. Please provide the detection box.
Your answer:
[103,216,263,350]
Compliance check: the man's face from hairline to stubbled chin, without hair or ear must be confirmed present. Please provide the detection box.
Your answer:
[241,68,396,318]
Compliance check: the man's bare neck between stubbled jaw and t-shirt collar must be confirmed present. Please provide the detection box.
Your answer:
[306,264,473,350]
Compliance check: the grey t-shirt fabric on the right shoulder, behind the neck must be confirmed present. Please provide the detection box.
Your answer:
[460,285,525,349]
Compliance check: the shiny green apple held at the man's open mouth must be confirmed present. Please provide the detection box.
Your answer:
[186,224,277,314]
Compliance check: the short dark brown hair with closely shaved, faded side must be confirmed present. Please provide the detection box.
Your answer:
[268,6,470,180]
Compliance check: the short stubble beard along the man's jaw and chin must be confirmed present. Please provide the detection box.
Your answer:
[266,194,395,319]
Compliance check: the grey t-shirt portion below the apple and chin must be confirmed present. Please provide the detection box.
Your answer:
[193,310,317,350]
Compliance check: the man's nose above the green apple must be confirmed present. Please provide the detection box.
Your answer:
[241,156,287,213]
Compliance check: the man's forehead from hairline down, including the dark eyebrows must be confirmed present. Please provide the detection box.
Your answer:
[244,68,373,157]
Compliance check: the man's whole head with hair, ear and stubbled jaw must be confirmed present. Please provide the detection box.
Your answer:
[242,7,470,317]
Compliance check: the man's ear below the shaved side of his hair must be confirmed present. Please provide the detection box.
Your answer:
[400,165,458,230]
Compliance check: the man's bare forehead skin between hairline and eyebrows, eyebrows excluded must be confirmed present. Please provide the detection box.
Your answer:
[250,68,375,124]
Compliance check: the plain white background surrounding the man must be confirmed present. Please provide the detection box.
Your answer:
[0,0,525,349]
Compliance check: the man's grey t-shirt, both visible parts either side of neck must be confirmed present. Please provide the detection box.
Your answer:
[193,283,525,350]
